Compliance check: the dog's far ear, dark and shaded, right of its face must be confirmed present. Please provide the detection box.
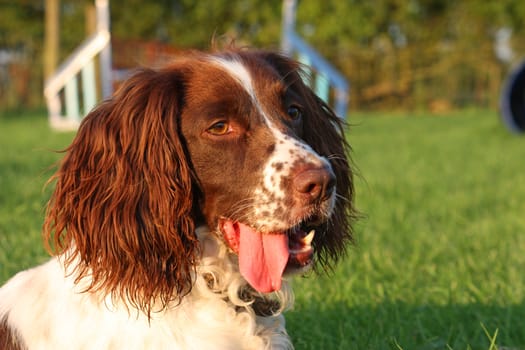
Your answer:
[258,53,357,267]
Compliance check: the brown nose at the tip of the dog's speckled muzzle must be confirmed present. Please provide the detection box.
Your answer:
[293,167,335,203]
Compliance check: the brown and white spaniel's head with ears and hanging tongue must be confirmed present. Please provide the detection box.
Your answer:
[44,51,353,311]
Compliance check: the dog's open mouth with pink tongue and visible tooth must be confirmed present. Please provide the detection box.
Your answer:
[219,219,315,293]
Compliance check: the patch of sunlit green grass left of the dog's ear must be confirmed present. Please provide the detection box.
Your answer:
[0,112,72,274]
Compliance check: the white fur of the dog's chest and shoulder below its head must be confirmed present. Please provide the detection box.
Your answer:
[0,228,292,350]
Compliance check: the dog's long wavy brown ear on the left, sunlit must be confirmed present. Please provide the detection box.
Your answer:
[44,67,198,316]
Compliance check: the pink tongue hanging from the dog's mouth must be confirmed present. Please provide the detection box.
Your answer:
[238,223,290,293]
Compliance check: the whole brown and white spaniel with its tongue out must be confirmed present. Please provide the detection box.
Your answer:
[0,49,354,350]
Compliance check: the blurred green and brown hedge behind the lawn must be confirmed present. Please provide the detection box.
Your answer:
[0,0,525,113]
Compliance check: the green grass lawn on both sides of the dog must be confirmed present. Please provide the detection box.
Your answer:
[0,111,525,350]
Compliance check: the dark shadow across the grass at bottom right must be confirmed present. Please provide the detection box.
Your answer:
[286,302,525,350]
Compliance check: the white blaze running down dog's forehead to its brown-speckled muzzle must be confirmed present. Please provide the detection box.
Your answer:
[212,57,330,228]
